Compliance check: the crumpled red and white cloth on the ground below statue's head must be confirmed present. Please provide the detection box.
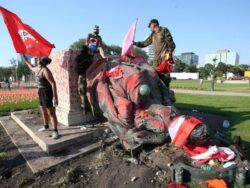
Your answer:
[183,144,235,164]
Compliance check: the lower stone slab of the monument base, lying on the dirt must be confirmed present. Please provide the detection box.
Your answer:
[0,116,103,173]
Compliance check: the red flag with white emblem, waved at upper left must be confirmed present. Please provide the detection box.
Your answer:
[0,7,55,57]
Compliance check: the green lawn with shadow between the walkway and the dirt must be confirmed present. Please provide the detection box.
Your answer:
[176,93,250,157]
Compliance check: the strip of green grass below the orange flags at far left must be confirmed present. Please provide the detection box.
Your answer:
[0,99,39,113]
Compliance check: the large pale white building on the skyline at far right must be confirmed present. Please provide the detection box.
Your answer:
[205,49,240,65]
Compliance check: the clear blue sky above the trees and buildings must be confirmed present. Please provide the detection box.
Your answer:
[0,0,250,67]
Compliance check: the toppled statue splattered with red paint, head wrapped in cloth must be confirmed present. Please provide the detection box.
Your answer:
[86,59,208,151]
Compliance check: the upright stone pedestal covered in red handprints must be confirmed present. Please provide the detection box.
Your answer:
[48,49,95,126]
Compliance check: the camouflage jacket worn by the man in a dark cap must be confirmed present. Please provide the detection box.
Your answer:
[136,27,175,66]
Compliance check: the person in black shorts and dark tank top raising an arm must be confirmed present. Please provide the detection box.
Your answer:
[24,55,59,139]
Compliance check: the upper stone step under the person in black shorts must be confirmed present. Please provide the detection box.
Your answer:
[11,110,104,154]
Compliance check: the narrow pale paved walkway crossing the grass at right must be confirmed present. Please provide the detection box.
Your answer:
[172,89,250,97]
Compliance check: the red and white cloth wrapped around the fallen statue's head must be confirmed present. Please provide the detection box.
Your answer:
[168,115,202,148]
